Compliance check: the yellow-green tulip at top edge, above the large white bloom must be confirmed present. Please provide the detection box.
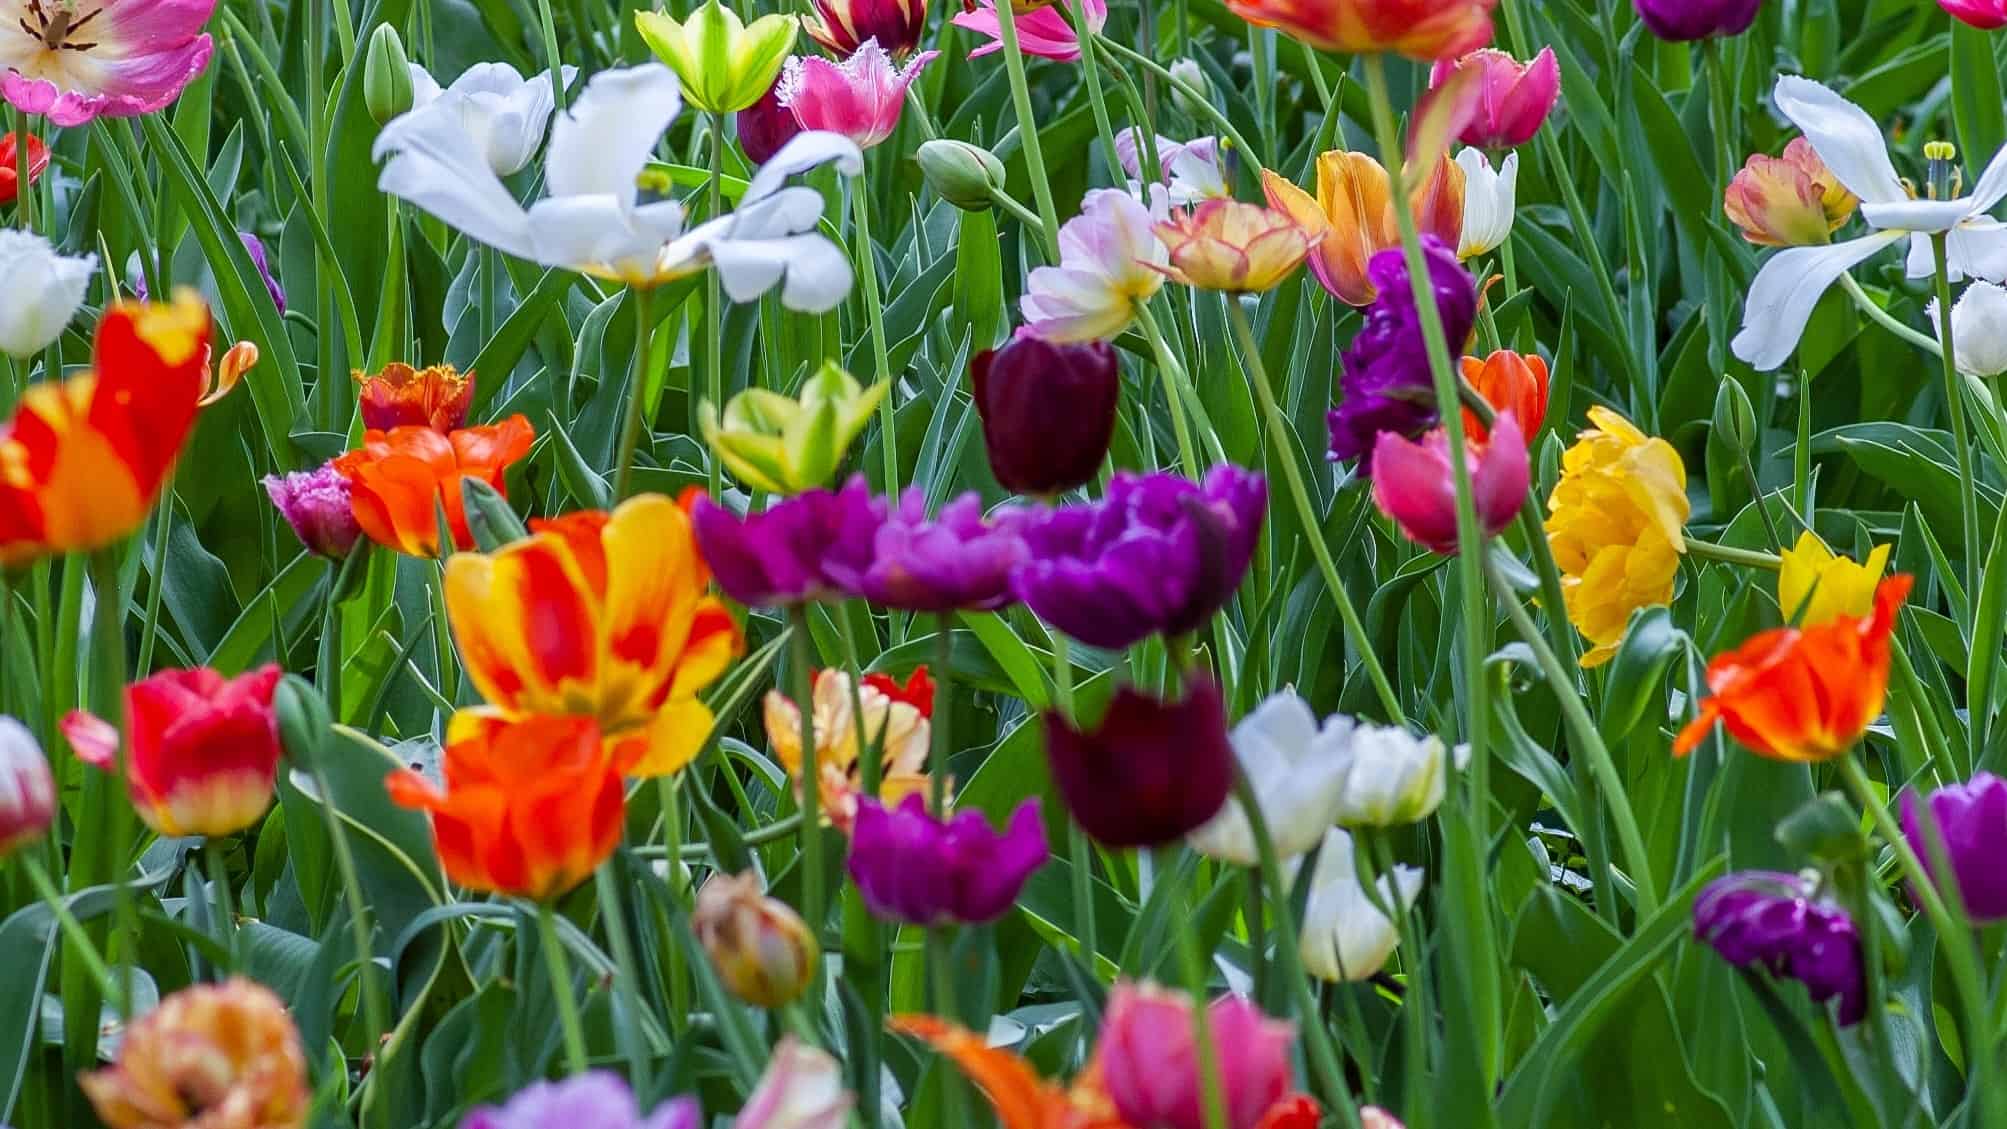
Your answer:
[634,0,797,114]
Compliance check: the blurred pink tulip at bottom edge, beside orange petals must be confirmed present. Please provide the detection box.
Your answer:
[1090,981,1297,1129]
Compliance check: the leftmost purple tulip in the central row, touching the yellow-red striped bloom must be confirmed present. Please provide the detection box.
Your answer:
[692,475,885,608]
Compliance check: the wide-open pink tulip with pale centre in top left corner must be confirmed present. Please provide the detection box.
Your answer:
[0,0,217,126]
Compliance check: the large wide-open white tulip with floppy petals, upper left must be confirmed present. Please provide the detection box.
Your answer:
[375,62,863,313]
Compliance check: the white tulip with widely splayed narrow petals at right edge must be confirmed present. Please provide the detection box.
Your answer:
[1732,74,2007,371]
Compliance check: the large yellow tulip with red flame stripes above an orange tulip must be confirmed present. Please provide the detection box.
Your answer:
[446,493,745,776]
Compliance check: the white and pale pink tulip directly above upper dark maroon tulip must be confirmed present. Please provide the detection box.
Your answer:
[1018,189,1170,345]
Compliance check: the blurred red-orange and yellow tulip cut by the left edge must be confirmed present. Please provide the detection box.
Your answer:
[0,291,209,566]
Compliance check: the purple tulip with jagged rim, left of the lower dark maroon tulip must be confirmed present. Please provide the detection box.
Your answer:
[849,794,1048,924]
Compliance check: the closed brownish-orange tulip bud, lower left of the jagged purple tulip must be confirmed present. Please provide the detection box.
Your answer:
[690,870,821,1007]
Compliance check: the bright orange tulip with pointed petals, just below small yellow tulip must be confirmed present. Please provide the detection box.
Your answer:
[1672,576,1911,762]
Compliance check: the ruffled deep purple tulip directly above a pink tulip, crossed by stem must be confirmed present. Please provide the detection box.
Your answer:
[1327,235,1477,475]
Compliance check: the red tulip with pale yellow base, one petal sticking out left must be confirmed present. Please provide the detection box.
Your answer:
[62,664,281,838]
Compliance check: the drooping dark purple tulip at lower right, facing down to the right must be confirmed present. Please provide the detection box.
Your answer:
[1694,870,1867,1027]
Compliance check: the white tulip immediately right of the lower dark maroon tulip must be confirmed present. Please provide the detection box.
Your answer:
[1188,690,1355,866]
